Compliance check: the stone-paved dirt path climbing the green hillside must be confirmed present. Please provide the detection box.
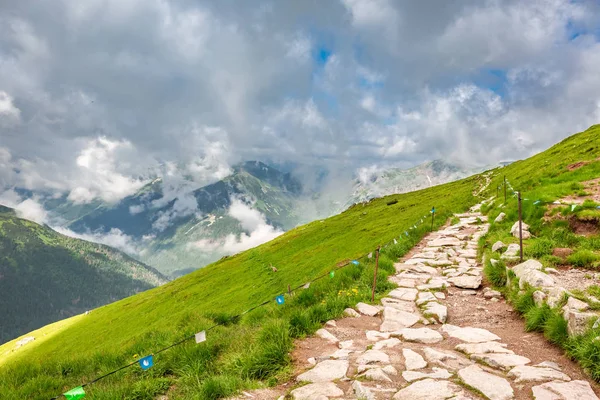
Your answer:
[232,208,600,400]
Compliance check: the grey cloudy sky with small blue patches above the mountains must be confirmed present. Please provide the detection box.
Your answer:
[0,0,600,203]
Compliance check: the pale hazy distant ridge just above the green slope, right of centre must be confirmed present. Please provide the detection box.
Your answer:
[346,160,491,205]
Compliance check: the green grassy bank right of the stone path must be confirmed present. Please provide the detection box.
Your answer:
[481,125,600,381]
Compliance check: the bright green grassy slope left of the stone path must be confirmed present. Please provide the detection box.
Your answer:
[0,172,480,398]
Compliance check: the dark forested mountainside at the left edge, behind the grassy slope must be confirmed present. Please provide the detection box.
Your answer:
[0,206,166,343]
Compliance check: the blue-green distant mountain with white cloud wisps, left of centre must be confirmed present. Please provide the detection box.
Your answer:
[44,161,306,276]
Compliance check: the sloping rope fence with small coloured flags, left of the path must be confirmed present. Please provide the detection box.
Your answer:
[51,207,436,400]
